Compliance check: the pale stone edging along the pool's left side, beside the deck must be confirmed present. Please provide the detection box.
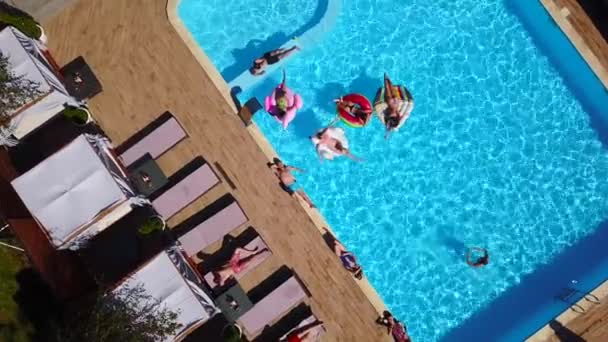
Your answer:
[166,0,387,314]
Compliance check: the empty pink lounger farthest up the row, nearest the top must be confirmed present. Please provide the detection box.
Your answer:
[120,117,188,166]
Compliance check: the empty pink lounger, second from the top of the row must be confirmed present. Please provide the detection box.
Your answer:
[152,164,220,220]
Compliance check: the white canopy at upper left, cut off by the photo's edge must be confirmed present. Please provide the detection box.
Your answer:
[0,26,78,143]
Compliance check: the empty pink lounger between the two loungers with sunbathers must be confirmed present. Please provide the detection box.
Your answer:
[237,276,306,337]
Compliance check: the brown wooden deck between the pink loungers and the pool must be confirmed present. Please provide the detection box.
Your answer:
[43,0,390,342]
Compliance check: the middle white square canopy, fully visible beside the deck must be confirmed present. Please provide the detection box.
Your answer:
[11,135,147,249]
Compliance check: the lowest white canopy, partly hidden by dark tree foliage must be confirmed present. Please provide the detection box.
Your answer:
[112,246,219,341]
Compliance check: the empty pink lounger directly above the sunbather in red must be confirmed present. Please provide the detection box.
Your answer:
[178,202,248,257]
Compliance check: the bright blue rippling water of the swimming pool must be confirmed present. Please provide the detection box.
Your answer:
[179,0,608,341]
